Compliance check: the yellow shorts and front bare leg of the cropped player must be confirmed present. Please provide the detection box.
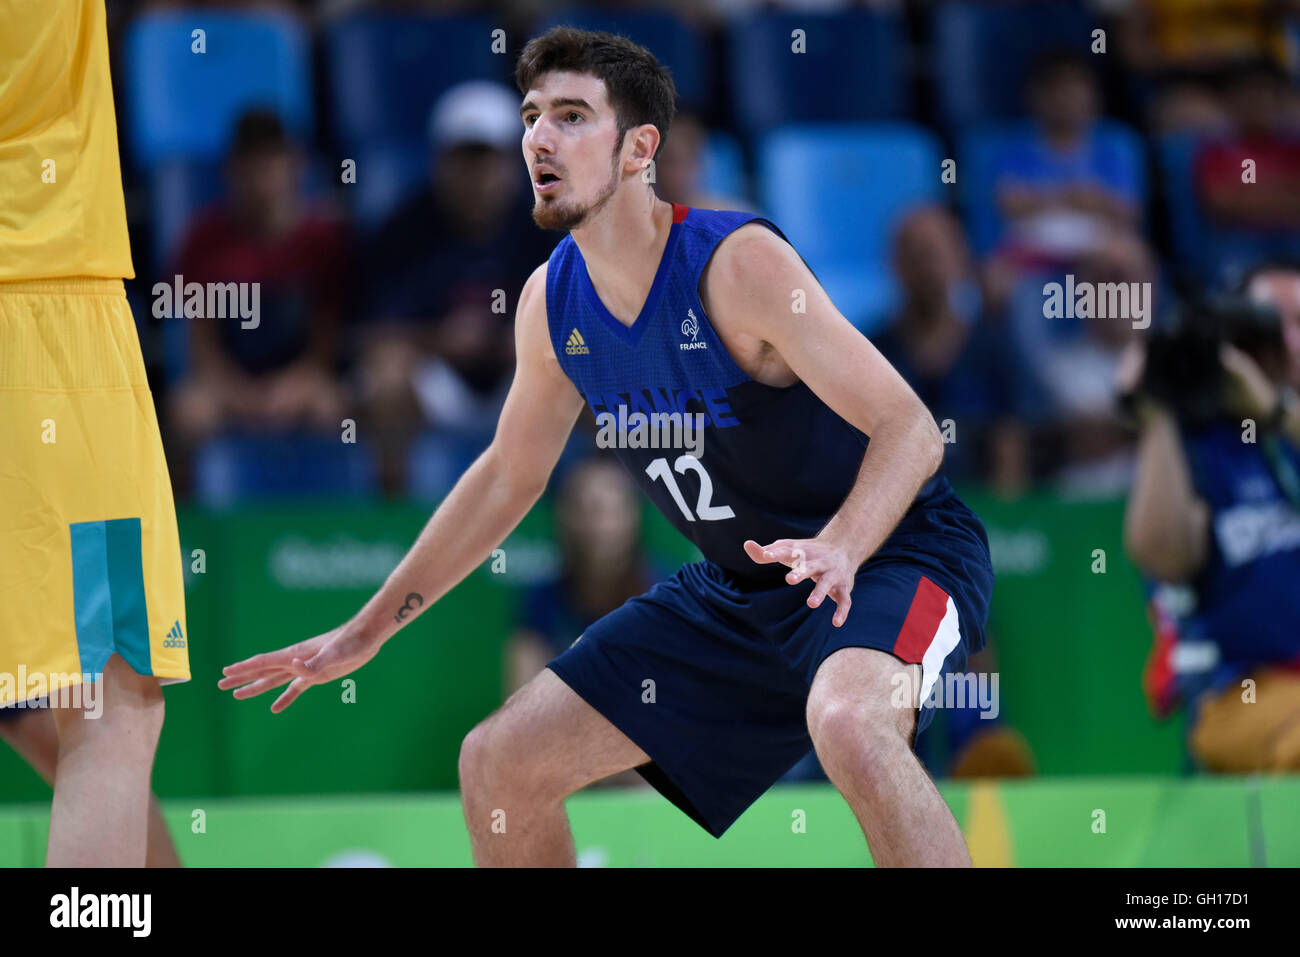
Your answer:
[0,278,190,866]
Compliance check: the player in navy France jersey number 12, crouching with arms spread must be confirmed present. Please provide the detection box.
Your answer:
[220,27,993,865]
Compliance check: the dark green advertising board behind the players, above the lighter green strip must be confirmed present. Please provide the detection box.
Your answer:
[0,495,1182,802]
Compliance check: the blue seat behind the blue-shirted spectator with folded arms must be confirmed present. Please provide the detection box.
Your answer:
[957,120,1148,256]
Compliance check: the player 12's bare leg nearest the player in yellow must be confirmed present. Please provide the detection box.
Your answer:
[460,670,649,867]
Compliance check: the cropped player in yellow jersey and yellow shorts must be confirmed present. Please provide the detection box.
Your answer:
[0,0,190,867]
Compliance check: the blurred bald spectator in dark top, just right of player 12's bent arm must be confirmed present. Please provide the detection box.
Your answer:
[874,207,1040,494]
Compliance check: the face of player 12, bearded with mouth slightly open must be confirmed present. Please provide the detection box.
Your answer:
[520,72,621,231]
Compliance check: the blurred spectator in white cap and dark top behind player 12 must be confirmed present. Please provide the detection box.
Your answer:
[359,81,555,492]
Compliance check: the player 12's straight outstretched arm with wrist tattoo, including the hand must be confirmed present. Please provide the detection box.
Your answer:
[217,264,582,713]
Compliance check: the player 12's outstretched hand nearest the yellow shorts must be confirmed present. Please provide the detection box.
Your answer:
[217,624,382,714]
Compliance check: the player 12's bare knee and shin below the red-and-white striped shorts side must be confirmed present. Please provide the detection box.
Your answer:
[807,648,971,867]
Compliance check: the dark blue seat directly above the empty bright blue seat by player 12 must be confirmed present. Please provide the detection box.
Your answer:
[727,10,911,135]
